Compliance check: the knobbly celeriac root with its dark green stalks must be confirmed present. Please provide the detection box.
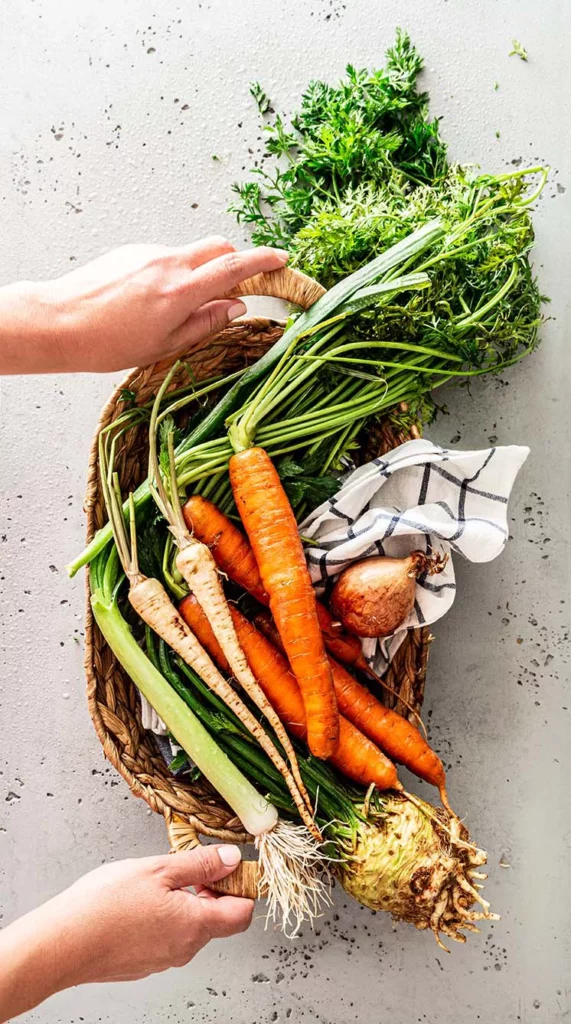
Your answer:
[157,630,495,945]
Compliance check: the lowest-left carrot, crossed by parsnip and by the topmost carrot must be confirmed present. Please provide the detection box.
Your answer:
[179,596,401,790]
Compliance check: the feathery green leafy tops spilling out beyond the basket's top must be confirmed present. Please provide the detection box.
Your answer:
[230,32,546,418]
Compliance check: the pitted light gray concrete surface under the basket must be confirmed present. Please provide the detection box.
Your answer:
[0,0,571,1024]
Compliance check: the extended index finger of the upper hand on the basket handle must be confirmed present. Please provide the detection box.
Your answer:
[177,246,289,310]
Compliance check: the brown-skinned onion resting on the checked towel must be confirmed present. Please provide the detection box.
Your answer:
[330,551,446,637]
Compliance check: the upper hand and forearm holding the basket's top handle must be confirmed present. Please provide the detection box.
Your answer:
[0,237,288,373]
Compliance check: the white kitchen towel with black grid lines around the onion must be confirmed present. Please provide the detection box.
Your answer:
[300,437,529,675]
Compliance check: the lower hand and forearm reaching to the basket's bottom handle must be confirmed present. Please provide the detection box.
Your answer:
[0,845,254,1021]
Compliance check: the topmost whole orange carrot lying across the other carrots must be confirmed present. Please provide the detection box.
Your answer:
[229,447,339,758]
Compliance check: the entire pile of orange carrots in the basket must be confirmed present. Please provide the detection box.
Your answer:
[179,491,451,813]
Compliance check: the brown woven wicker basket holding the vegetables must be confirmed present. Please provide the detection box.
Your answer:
[85,269,430,850]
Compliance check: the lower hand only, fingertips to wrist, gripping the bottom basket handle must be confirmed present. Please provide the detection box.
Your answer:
[57,846,254,984]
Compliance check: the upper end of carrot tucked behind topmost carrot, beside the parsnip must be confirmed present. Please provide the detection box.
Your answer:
[182,495,268,606]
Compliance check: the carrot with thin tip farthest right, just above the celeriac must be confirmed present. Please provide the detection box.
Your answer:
[255,612,452,813]
